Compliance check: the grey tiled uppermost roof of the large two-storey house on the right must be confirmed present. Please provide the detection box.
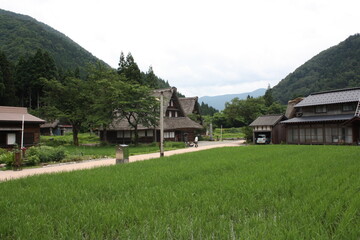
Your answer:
[295,87,360,107]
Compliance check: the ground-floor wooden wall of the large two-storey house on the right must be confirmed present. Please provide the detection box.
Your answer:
[286,124,356,144]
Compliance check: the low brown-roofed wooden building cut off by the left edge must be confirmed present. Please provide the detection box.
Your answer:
[0,106,45,148]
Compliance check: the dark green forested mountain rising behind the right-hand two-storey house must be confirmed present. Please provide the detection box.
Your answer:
[272,34,360,104]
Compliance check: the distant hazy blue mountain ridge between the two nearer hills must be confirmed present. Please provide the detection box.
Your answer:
[198,88,266,111]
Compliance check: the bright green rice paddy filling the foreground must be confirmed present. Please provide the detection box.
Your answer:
[0,145,360,239]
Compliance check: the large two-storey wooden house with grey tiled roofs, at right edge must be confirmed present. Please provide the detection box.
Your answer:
[281,87,360,144]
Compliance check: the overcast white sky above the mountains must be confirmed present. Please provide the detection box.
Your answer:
[0,0,360,97]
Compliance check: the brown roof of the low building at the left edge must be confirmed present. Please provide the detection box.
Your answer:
[0,106,45,123]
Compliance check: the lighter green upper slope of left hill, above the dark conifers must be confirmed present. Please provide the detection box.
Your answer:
[0,9,108,71]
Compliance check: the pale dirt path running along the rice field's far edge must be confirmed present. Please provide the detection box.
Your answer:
[0,141,243,181]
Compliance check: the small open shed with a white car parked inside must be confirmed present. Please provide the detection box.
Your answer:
[249,114,286,144]
